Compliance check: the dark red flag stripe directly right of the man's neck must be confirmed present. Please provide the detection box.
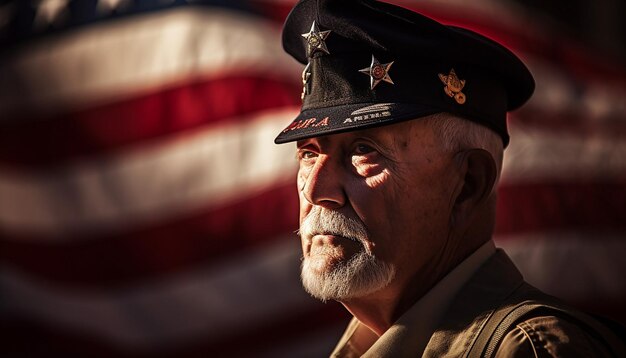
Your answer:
[495,178,626,235]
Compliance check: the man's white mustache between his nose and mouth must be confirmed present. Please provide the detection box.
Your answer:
[298,206,369,252]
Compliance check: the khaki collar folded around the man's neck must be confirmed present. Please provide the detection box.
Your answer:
[331,242,523,357]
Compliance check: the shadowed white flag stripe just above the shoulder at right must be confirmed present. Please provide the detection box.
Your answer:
[496,232,626,300]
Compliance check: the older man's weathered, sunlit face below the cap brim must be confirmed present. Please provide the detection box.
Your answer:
[297,120,458,301]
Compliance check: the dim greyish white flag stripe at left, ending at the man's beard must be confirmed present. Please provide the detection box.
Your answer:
[0,237,315,348]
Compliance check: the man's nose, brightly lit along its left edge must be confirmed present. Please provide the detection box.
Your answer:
[301,155,346,209]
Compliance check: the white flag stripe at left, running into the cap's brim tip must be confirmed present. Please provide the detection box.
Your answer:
[0,108,297,239]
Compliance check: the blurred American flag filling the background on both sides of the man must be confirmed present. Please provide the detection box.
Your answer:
[0,0,626,357]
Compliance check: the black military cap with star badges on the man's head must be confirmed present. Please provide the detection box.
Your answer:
[275,0,535,146]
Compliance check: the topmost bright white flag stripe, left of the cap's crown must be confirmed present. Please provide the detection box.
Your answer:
[0,7,299,116]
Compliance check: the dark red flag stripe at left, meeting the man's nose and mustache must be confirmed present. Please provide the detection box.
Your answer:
[0,184,298,288]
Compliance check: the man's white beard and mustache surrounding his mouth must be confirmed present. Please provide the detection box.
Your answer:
[300,207,395,301]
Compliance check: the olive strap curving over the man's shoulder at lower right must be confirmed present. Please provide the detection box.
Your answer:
[466,300,626,358]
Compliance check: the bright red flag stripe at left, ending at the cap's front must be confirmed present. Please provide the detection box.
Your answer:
[0,76,300,167]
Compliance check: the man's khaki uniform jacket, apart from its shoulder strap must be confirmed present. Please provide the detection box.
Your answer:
[331,250,613,358]
